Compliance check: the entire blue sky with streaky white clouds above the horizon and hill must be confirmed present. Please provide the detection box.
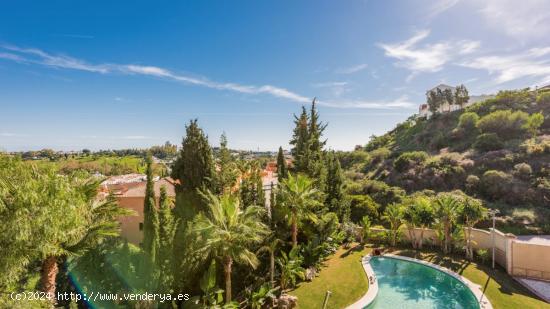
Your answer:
[0,0,550,151]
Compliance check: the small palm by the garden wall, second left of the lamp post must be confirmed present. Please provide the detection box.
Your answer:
[434,193,461,254]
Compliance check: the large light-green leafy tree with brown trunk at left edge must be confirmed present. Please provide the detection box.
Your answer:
[0,156,132,295]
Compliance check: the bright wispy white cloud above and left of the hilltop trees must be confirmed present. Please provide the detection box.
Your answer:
[378,30,480,74]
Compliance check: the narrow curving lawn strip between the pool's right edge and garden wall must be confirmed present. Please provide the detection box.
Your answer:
[392,250,550,309]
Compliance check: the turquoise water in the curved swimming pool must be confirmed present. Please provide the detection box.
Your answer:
[367,256,479,309]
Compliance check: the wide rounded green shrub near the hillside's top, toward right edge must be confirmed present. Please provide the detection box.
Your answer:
[477,110,529,139]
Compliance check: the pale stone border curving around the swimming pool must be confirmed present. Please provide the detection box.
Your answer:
[346,254,493,309]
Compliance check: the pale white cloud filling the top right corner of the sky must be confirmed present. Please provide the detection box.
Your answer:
[478,0,550,41]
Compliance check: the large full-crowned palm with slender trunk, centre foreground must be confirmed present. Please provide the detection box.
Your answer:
[192,191,269,303]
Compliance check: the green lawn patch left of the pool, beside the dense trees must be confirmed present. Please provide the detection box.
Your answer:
[289,246,370,309]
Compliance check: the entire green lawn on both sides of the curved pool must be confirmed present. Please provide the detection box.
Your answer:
[290,247,550,309]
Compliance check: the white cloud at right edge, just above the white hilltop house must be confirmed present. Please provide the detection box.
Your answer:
[461,47,550,84]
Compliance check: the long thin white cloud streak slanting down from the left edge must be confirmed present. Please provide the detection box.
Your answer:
[0,45,414,108]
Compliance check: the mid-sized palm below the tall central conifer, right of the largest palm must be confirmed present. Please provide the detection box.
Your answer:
[280,173,321,247]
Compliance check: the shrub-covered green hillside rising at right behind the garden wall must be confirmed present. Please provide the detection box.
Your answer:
[340,89,550,233]
